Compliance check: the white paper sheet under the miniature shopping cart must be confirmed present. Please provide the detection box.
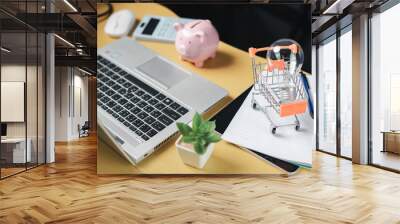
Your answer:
[222,90,315,167]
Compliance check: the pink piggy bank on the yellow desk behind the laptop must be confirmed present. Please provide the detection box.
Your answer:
[174,20,219,67]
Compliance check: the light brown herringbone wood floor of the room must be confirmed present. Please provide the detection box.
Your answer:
[0,134,400,223]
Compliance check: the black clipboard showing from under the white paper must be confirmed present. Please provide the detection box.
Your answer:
[210,86,300,173]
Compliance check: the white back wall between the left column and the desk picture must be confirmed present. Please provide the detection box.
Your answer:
[55,67,88,141]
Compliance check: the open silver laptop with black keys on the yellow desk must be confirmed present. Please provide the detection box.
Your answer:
[97,38,227,164]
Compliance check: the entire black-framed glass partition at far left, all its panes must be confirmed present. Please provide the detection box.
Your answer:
[0,1,46,179]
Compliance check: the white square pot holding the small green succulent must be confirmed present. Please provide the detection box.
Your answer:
[175,135,215,169]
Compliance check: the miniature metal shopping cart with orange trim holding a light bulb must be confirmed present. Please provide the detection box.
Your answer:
[249,40,307,134]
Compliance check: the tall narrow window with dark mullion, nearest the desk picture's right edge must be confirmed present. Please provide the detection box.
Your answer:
[317,24,353,159]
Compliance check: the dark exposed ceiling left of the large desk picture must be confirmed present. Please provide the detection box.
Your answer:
[0,0,97,73]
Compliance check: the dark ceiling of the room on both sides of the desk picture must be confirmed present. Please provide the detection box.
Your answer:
[0,0,394,71]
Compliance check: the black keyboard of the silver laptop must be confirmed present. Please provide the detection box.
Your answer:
[97,56,188,141]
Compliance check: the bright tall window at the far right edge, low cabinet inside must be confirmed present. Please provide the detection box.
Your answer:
[370,4,400,170]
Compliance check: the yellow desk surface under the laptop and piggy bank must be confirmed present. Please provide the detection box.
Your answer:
[97,3,286,175]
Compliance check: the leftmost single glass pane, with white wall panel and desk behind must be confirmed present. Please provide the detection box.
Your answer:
[0,32,27,177]
